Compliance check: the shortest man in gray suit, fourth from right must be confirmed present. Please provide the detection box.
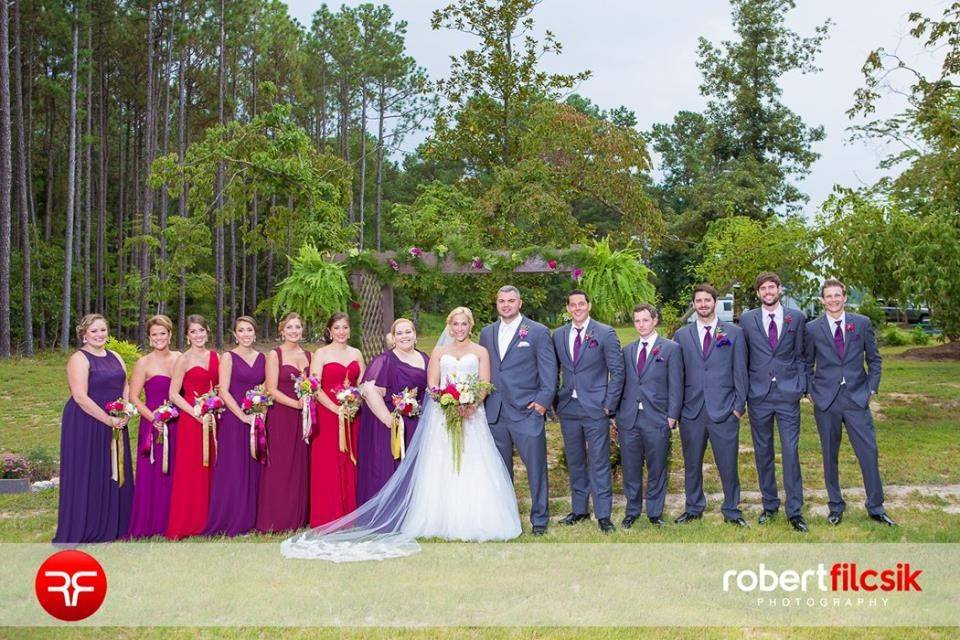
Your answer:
[617,303,683,529]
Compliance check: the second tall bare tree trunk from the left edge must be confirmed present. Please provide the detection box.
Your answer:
[13,0,33,358]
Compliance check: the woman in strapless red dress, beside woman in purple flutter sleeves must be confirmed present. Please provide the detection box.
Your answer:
[310,313,363,527]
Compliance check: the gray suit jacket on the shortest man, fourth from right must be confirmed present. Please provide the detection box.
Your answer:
[617,335,683,429]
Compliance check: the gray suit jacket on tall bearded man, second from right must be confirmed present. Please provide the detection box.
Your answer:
[740,307,807,402]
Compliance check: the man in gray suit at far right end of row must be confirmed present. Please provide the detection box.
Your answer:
[804,280,897,527]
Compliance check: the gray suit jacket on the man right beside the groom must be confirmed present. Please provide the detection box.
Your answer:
[553,318,623,417]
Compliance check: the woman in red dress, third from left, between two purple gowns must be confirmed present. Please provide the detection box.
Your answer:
[166,315,220,540]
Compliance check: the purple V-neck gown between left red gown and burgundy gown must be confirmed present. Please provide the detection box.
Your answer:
[203,353,267,536]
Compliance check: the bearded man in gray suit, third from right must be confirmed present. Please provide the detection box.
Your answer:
[675,284,749,527]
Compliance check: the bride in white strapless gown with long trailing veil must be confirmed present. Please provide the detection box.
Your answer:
[281,307,521,562]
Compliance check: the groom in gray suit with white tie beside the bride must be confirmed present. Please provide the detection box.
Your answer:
[480,285,557,536]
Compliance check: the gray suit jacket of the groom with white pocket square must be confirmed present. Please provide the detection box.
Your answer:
[480,316,557,422]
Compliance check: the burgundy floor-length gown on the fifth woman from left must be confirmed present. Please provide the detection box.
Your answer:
[257,347,311,532]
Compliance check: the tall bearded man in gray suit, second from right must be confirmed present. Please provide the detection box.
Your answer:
[740,271,808,533]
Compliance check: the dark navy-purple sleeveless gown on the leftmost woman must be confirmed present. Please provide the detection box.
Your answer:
[53,349,133,544]
